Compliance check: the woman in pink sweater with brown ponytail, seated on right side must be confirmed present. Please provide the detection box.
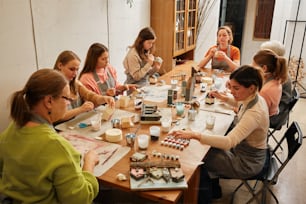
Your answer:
[253,49,288,116]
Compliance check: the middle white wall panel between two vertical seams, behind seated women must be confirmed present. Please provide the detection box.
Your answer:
[32,0,108,68]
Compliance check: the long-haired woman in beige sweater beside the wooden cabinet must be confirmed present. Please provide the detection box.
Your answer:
[123,27,162,87]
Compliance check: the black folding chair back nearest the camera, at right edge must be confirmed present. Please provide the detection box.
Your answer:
[268,121,303,182]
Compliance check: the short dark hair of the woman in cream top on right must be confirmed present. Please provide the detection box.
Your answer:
[230,65,263,91]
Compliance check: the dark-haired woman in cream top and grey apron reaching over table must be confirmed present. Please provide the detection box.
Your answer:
[169,65,269,203]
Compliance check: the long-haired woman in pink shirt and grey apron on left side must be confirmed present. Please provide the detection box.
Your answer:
[79,43,136,96]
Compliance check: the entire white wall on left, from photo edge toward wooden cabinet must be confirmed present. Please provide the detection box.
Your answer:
[0,0,150,132]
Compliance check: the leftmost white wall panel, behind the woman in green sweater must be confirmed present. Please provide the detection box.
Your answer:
[0,0,36,131]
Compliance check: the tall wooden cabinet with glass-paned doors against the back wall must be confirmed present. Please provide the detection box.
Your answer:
[151,0,198,73]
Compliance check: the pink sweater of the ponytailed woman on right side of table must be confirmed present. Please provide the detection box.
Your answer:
[259,80,282,116]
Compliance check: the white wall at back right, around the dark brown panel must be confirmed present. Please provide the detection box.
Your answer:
[241,0,306,64]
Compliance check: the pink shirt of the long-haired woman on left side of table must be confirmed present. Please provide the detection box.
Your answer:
[80,65,120,95]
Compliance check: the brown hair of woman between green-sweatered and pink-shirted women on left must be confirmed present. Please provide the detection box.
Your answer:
[53,50,81,94]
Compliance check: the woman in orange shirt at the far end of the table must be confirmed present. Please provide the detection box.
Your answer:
[198,26,240,72]
